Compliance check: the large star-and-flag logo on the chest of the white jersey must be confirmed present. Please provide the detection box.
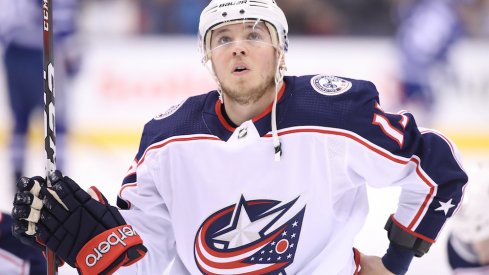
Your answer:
[194,196,306,275]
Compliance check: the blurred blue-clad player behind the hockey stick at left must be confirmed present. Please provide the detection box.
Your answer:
[0,0,79,185]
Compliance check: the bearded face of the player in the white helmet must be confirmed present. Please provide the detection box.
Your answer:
[210,21,277,104]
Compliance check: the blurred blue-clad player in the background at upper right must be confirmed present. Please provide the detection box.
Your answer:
[396,0,464,123]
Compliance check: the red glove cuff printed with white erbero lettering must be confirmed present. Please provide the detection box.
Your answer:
[76,224,143,274]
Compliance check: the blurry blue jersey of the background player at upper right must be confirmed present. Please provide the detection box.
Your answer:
[396,0,464,85]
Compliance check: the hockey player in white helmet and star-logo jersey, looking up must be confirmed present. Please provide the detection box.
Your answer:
[13,0,467,275]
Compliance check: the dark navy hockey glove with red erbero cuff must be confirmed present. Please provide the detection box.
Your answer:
[12,171,147,274]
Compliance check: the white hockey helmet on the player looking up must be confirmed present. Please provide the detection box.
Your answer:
[199,0,289,63]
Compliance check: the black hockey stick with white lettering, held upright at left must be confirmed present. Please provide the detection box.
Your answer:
[42,0,58,275]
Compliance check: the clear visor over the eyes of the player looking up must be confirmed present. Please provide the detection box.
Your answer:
[206,19,277,61]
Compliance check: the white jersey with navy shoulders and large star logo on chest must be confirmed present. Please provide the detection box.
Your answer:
[114,75,467,275]
